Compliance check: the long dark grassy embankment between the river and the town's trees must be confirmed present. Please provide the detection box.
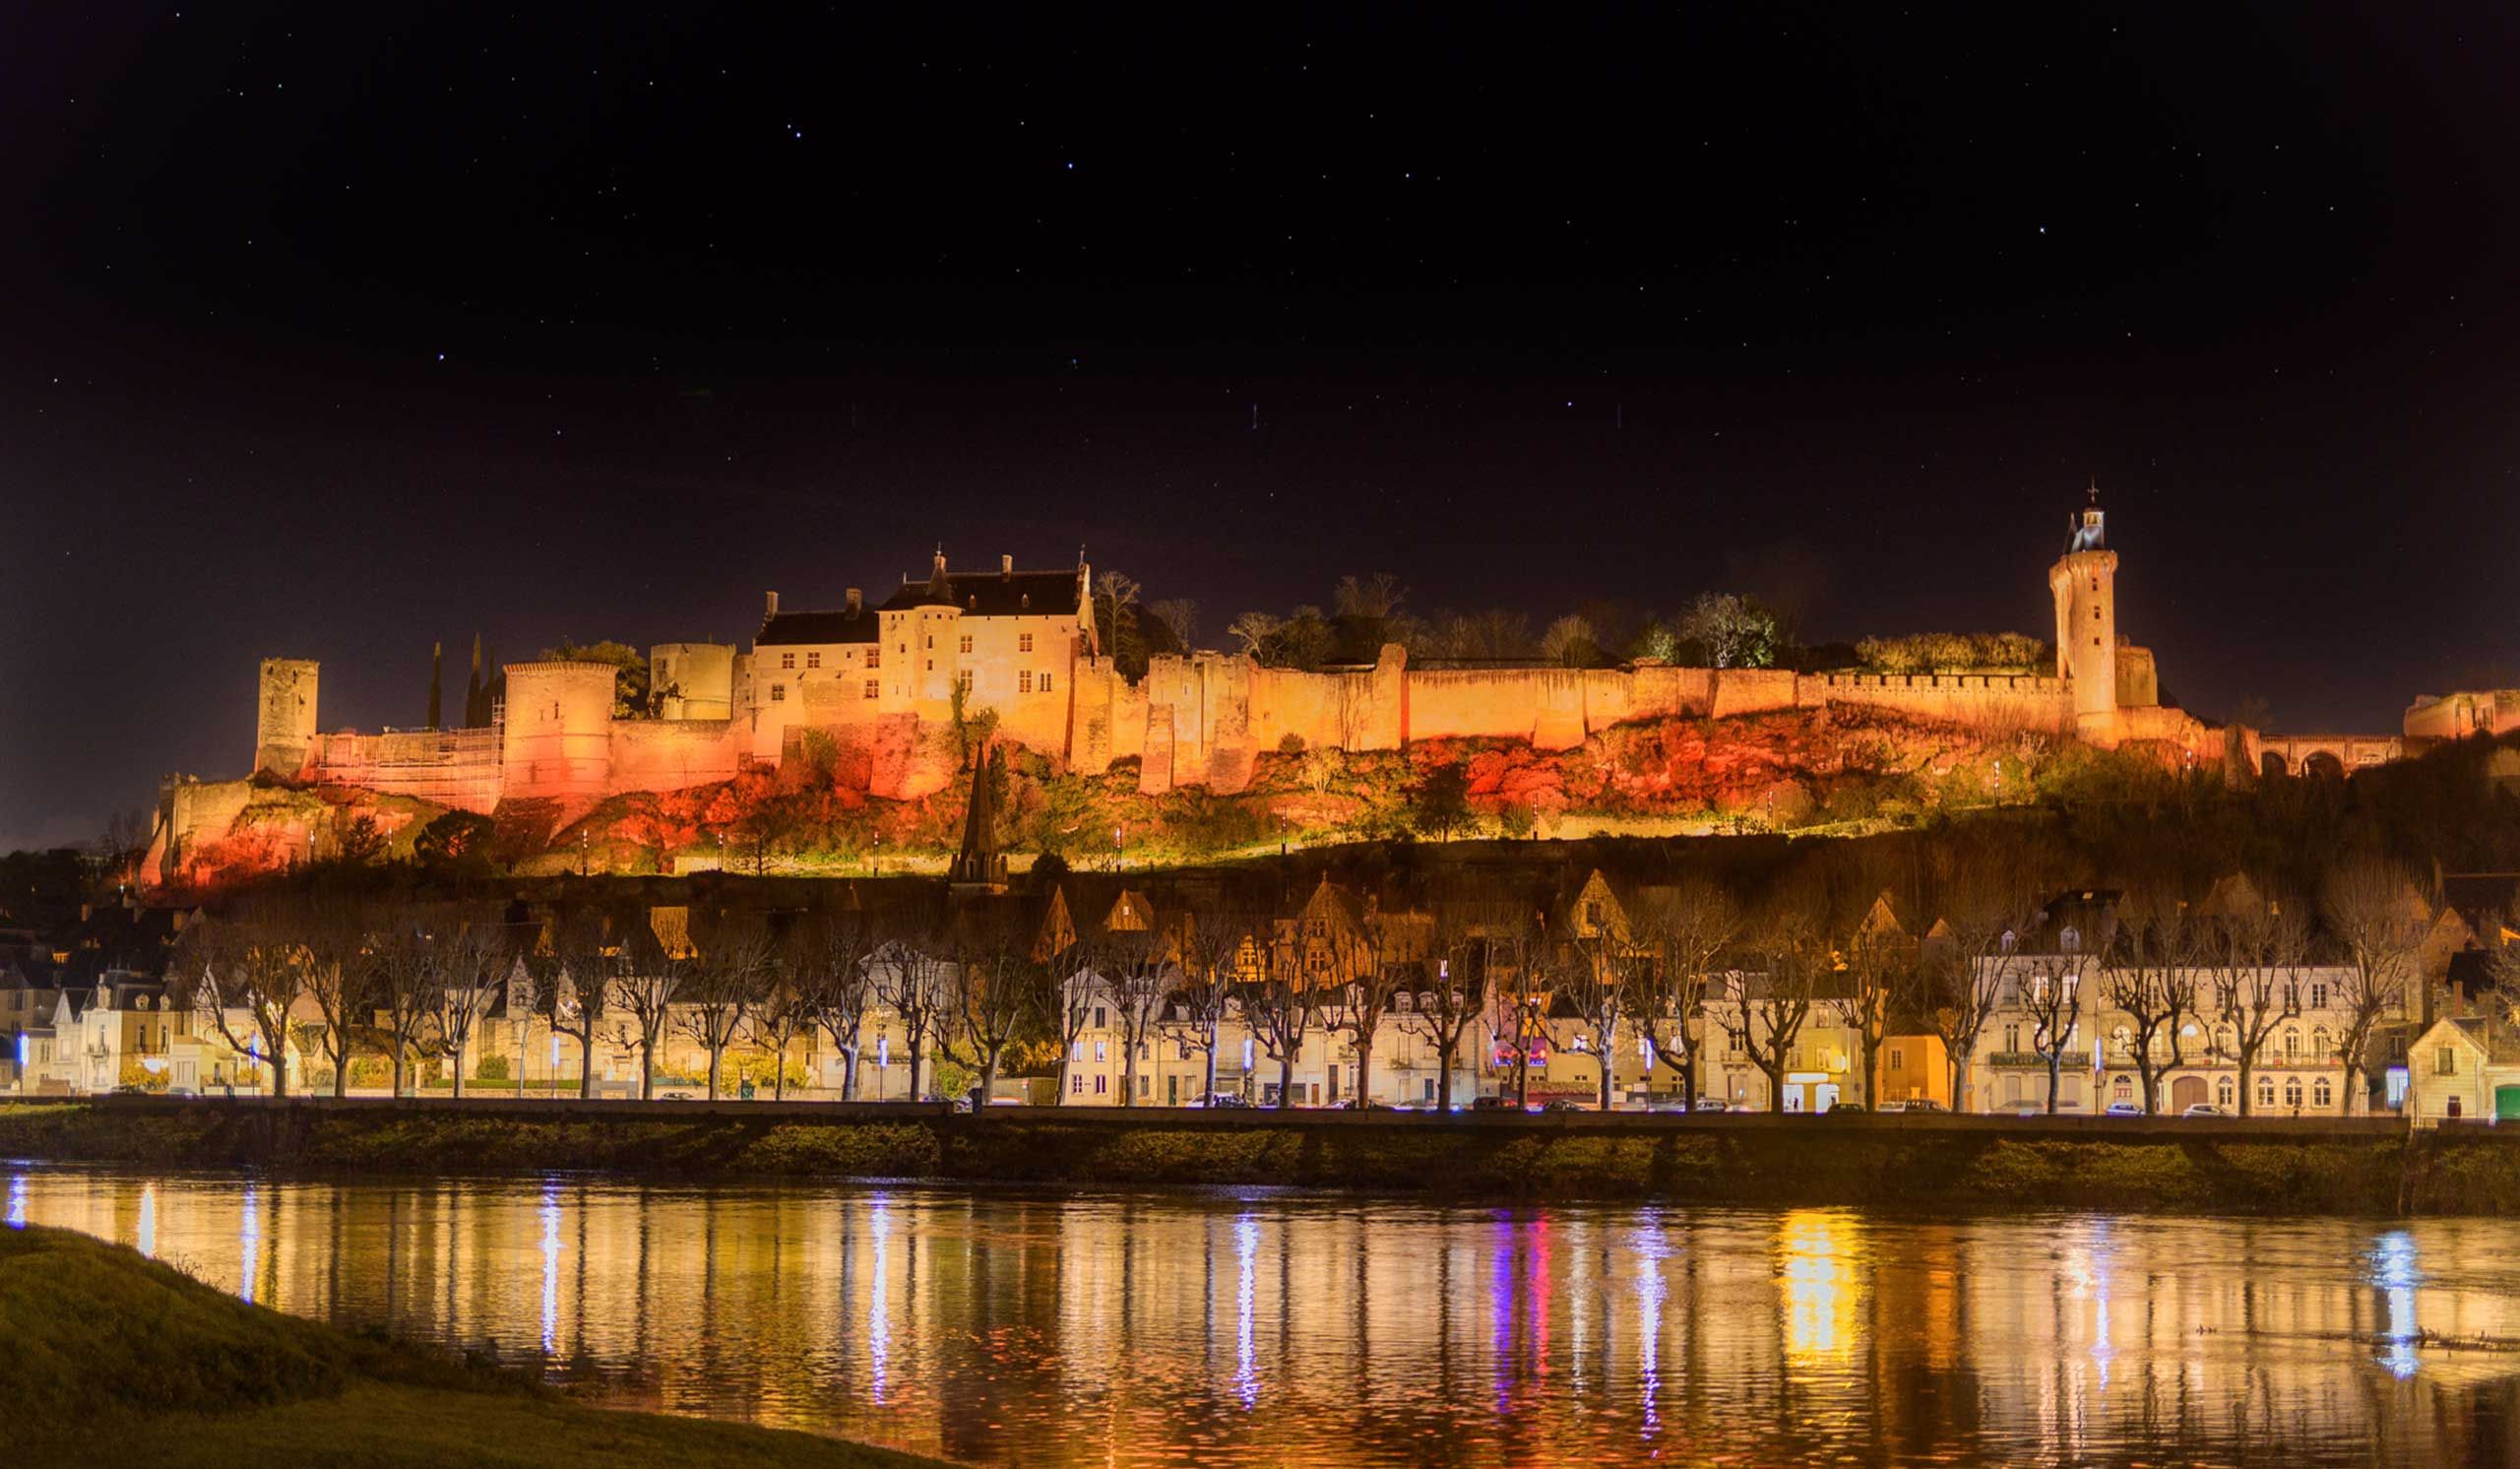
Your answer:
[0,1101,2520,1215]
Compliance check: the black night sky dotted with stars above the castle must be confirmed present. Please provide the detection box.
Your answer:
[0,0,2520,847]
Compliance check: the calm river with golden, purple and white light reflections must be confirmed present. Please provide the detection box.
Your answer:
[0,1164,2520,1469]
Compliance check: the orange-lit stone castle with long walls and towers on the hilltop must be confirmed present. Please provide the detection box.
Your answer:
[143,491,2439,886]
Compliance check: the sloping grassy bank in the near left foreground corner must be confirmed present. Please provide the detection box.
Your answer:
[0,1227,935,1469]
